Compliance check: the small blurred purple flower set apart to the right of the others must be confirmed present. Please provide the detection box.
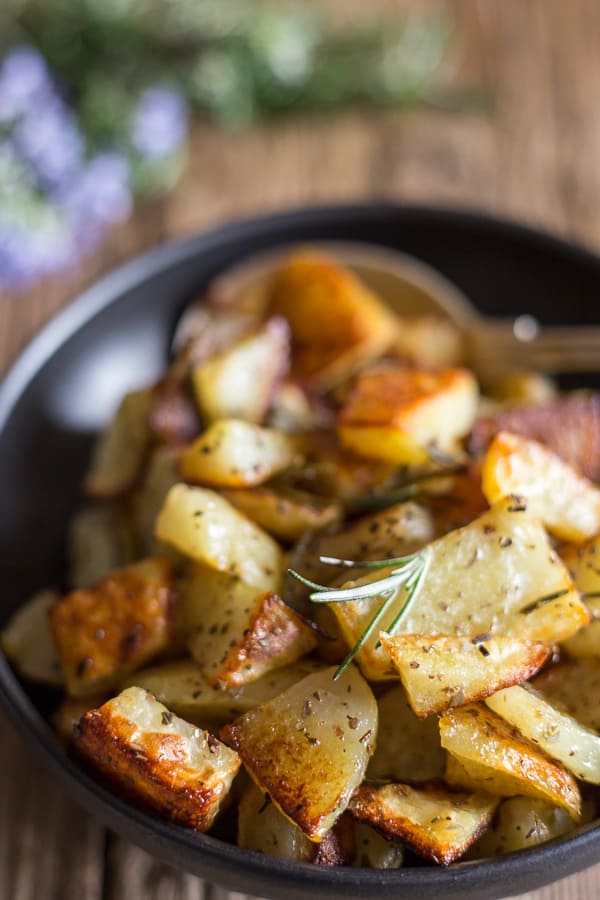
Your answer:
[131,85,187,159]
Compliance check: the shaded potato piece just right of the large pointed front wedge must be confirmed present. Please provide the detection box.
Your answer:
[367,684,446,784]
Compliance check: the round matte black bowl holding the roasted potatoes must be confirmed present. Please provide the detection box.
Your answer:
[0,203,600,900]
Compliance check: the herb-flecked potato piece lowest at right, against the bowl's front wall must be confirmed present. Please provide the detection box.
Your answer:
[469,797,575,859]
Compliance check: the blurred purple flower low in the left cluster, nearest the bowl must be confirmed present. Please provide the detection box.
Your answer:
[57,151,132,232]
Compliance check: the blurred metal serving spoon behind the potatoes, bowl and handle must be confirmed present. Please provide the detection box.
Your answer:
[173,241,600,380]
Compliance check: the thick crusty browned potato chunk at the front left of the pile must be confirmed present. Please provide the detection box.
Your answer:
[75,687,240,831]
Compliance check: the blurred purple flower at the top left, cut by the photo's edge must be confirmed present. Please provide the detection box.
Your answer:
[0,44,54,122]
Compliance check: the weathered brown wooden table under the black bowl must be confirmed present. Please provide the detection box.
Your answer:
[0,0,600,900]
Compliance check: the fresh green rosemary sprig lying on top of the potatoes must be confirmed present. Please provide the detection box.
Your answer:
[288,547,431,681]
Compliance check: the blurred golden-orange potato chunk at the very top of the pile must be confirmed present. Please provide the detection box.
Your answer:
[269,250,398,388]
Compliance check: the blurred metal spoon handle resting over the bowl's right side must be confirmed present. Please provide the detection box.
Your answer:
[466,319,600,378]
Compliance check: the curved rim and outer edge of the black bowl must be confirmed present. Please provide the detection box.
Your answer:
[0,201,600,898]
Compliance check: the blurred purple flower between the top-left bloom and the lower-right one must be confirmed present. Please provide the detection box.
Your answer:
[13,96,83,188]
